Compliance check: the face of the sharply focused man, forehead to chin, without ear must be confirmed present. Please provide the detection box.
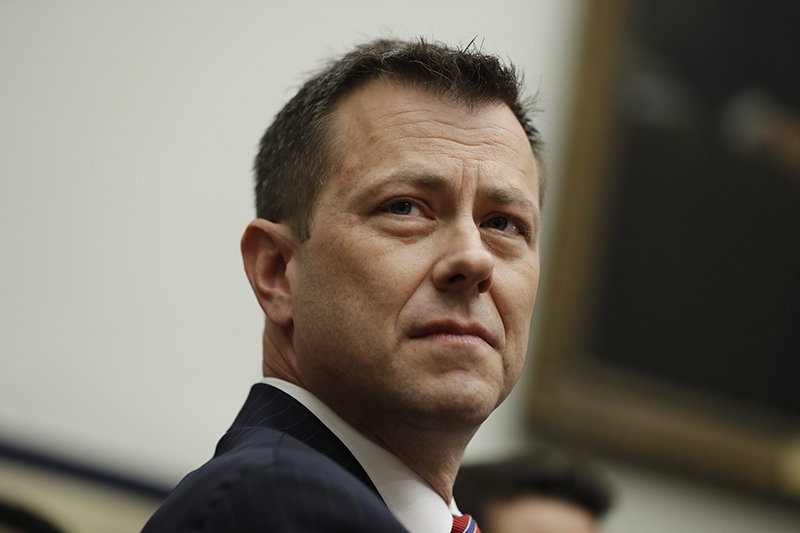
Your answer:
[291,82,539,430]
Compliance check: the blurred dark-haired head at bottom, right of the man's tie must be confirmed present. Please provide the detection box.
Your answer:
[453,447,612,533]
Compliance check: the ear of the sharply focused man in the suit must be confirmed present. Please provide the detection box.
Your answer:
[242,218,300,327]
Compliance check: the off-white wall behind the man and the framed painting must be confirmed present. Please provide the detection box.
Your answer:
[0,0,800,532]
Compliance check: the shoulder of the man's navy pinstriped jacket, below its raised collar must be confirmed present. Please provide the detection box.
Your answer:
[144,427,404,533]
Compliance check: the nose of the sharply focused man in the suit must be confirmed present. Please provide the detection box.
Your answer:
[433,220,495,294]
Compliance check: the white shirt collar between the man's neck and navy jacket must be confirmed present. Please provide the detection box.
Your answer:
[262,378,461,533]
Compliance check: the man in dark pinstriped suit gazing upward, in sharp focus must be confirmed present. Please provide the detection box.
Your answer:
[145,40,542,533]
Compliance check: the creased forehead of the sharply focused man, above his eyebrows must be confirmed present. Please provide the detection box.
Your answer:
[332,81,538,200]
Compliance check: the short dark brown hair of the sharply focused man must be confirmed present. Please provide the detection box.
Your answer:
[255,39,544,242]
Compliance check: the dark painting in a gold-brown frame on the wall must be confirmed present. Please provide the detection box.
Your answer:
[530,0,800,499]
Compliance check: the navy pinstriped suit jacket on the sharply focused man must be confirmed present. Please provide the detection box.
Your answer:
[143,383,407,533]
